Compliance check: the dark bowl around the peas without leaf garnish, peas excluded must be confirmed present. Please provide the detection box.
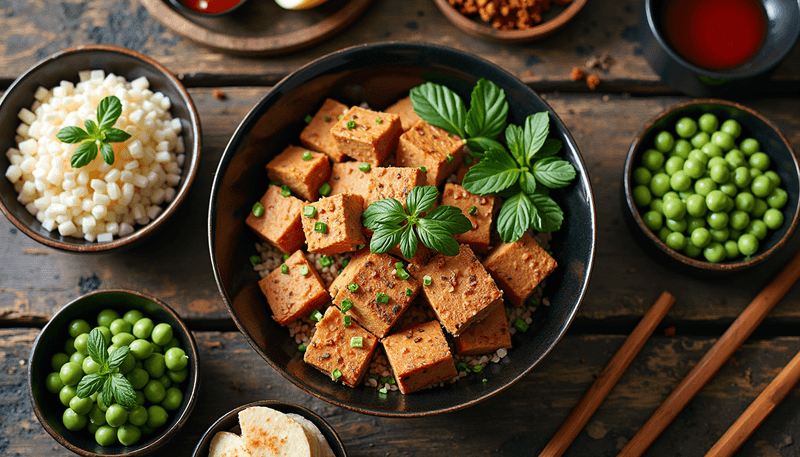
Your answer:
[622,99,800,275]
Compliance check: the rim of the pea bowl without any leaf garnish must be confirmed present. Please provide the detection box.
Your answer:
[622,98,800,273]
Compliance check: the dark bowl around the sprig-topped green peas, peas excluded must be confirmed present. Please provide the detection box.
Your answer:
[28,289,200,457]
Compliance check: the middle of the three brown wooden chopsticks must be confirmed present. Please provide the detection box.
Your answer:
[618,251,800,457]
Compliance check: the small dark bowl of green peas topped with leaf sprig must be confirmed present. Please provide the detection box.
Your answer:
[28,289,200,456]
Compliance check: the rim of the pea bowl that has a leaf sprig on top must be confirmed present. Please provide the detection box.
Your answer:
[27,288,200,457]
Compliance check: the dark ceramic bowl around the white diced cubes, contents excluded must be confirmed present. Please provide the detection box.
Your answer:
[0,45,201,253]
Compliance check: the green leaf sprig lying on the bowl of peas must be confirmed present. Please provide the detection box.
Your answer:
[77,329,137,409]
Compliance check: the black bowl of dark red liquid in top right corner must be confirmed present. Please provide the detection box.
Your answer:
[640,0,800,97]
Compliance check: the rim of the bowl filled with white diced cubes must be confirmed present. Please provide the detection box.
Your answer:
[0,45,202,253]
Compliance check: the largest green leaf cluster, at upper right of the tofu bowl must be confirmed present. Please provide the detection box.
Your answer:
[410,79,576,242]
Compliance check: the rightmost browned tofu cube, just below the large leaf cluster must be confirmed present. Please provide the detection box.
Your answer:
[483,233,558,306]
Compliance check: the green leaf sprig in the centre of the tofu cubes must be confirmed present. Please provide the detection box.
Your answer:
[361,186,472,259]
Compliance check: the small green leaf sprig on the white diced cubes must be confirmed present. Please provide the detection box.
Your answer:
[56,95,131,168]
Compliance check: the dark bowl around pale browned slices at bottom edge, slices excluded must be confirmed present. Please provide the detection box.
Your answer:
[192,400,347,457]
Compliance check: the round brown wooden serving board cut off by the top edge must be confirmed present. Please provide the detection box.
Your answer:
[140,0,372,56]
